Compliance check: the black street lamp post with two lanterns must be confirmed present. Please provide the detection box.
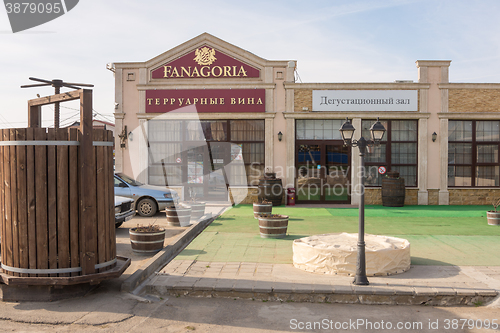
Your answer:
[339,118,385,286]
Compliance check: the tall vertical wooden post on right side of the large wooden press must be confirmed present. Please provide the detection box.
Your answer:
[79,89,97,275]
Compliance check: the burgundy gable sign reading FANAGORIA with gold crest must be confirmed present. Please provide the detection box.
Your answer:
[151,46,260,79]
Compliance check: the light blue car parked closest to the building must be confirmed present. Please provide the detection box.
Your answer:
[115,173,179,217]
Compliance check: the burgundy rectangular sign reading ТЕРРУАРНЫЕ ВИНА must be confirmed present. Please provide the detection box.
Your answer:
[146,89,266,113]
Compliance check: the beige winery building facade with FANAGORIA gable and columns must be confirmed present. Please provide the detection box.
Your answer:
[114,33,500,205]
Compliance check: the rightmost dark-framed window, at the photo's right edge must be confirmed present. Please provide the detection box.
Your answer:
[448,120,500,187]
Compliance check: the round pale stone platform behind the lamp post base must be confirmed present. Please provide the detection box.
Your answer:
[293,233,411,276]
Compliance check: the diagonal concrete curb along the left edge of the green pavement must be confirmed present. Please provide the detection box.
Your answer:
[121,216,217,292]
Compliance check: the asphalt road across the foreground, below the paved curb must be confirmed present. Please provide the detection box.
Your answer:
[0,281,500,333]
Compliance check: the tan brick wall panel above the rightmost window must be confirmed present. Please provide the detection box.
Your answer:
[448,89,500,112]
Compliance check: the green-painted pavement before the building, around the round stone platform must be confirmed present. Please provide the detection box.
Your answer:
[176,205,500,266]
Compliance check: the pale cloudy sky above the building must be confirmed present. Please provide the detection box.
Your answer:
[0,0,500,128]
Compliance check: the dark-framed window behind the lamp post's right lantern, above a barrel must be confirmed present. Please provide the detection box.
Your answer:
[361,120,418,186]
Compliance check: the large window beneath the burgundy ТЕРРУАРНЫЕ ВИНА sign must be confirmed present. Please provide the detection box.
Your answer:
[148,120,265,185]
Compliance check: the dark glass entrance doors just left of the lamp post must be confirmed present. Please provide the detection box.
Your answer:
[296,141,351,203]
